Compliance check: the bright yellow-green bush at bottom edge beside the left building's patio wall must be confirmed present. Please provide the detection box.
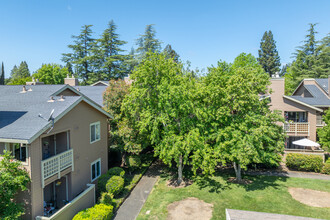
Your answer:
[73,204,113,220]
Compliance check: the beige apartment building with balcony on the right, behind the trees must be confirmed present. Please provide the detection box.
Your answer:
[270,76,330,150]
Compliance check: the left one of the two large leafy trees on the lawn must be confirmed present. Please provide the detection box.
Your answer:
[122,52,204,184]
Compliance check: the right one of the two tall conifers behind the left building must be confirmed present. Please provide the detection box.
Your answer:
[98,20,127,80]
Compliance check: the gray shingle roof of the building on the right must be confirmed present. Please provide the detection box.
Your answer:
[290,85,330,106]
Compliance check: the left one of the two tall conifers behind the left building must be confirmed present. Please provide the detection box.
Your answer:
[62,25,96,84]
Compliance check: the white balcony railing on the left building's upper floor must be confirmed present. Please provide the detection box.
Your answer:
[41,149,73,188]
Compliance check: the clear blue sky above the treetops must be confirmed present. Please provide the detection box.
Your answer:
[0,0,330,77]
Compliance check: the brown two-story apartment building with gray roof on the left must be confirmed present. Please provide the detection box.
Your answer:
[0,84,111,220]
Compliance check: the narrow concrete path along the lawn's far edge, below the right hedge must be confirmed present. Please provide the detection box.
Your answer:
[244,171,330,180]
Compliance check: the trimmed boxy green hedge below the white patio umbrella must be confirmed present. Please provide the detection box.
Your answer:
[286,153,323,172]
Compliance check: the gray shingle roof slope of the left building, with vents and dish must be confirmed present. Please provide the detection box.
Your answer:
[0,85,81,140]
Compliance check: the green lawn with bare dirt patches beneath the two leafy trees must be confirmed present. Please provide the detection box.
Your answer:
[137,174,330,220]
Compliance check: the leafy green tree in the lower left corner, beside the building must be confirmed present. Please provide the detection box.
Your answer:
[0,151,30,220]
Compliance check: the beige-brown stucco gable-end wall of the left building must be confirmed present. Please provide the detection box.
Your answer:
[30,102,108,218]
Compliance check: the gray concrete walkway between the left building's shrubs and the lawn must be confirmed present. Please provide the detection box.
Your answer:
[113,165,159,220]
